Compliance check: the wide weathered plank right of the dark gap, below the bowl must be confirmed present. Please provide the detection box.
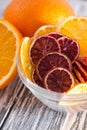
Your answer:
[2,81,66,130]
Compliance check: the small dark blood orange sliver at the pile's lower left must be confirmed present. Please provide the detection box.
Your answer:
[32,70,44,87]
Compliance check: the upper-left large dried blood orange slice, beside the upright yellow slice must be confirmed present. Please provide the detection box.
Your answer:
[30,36,60,64]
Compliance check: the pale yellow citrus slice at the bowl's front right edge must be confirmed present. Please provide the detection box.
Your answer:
[68,83,87,94]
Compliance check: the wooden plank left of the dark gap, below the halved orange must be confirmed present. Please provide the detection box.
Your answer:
[0,77,24,128]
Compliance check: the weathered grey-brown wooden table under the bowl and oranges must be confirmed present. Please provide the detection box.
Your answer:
[0,0,87,130]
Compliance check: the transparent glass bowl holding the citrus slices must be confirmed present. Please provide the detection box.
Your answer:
[17,43,87,112]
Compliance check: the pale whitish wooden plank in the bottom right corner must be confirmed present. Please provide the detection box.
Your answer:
[63,111,87,130]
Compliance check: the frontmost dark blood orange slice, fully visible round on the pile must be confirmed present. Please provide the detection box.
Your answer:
[44,67,74,93]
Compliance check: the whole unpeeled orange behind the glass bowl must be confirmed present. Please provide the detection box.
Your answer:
[4,0,74,37]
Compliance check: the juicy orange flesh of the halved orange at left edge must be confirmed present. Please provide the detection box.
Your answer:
[0,24,16,80]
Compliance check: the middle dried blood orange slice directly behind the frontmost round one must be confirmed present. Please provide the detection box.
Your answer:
[37,52,71,79]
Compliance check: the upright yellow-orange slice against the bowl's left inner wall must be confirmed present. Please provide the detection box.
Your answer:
[20,37,34,80]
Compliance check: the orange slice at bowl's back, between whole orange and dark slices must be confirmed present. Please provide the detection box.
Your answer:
[34,25,57,38]
